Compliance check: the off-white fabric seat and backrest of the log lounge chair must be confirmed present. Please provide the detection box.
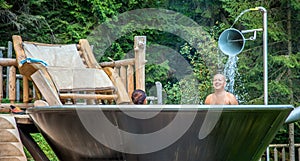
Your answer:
[23,42,115,92]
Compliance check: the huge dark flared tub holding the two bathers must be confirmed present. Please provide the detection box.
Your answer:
[27,105,293,161]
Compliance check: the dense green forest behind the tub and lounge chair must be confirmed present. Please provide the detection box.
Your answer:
[0,0,300,160]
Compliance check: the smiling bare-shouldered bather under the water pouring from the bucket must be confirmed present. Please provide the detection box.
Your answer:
[205,74,238,105]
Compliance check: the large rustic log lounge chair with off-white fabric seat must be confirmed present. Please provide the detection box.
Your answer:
[13,35,130,105]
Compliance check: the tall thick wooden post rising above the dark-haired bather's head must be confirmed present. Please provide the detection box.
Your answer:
[134,36,146,91]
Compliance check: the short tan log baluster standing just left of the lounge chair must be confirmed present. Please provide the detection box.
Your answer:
[9,66,16,103]
